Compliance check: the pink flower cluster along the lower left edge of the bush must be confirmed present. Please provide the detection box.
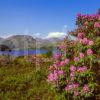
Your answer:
[47,54,69,83]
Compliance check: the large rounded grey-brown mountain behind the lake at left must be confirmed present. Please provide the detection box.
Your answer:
[0,35,36,49]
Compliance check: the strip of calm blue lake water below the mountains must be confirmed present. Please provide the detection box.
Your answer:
[0,49,47,56]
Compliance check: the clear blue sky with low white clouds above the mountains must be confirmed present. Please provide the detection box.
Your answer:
[0,0,100,38]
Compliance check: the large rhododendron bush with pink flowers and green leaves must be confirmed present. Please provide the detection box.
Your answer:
[47,9,100,100]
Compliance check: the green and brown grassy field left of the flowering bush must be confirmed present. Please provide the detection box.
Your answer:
[0,58,53,100]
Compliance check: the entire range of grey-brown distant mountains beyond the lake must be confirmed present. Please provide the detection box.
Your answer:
[0,35,62,49]
